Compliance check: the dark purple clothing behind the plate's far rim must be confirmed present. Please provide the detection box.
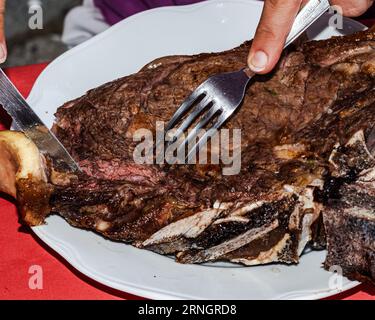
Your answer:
[94,0,203,25]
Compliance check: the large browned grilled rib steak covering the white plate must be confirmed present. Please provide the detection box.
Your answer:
[0,30,375,279]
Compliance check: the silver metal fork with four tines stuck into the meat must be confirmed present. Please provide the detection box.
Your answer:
[165,0,330,161]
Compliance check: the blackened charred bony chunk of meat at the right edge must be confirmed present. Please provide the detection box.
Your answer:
[323,130,375,281]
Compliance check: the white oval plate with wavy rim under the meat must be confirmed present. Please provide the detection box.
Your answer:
[28,0,363,299]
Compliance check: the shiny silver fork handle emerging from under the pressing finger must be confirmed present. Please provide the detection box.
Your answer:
[243,0,331,78]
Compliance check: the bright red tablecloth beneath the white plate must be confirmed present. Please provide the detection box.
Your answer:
[0,64,375,300]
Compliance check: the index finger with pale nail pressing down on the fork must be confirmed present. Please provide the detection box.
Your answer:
[248,0,302,74]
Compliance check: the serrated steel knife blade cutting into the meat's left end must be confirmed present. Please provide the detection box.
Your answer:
[0,68,80,172]
